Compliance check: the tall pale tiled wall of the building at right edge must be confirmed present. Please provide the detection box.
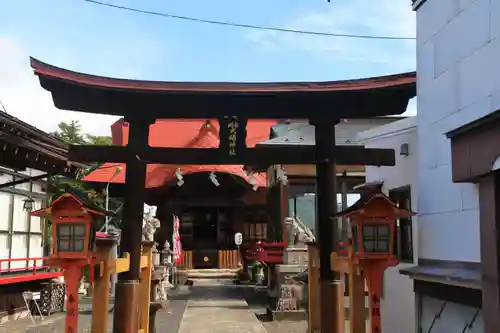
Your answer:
[417,0,500,262]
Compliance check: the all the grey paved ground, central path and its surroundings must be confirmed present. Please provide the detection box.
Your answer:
[0,279,316,333]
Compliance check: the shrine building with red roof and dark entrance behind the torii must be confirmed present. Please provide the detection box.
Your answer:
[84,117,401,269]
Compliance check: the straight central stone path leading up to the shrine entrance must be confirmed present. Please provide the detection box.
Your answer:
[178,280,266,333]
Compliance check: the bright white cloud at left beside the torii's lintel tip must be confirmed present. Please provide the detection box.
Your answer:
[0,36,118,135]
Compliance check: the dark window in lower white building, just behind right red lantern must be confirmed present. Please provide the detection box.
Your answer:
[389,185,413,262]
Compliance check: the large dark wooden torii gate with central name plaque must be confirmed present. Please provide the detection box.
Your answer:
[31,58,416,333]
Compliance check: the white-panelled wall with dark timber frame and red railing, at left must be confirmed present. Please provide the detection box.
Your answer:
[0,166,47,324]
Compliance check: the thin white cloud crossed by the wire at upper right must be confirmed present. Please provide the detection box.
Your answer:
[246,0,415,71]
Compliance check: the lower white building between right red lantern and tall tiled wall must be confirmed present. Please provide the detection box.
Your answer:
[358,117,419,333]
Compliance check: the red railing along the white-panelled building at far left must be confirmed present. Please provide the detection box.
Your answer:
[0,257,62,285]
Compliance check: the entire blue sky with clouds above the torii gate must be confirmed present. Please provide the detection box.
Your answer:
[0,0,415,134]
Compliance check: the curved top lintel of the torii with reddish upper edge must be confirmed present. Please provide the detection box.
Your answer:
[31,58,416,121]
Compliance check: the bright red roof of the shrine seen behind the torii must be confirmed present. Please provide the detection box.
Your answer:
[83,119,277,188]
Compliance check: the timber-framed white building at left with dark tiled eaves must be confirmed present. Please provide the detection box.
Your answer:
[0,112,83,324]
